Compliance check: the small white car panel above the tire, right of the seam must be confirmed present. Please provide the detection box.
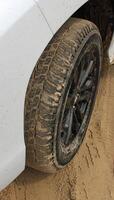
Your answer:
[34,0,88,33]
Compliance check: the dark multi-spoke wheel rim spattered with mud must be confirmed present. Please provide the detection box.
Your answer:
[59,46,100,153]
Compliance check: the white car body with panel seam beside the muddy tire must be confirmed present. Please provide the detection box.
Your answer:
[0,0,114,190]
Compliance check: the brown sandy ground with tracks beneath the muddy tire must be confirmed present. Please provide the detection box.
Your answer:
[0,58,114,200]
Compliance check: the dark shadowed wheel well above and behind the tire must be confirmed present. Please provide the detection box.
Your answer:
[73,0,114,41]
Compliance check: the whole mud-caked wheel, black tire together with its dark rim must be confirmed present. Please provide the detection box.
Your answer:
[25,18,102,173]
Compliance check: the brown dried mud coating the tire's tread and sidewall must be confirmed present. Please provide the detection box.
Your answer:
[25,18,102,173]
